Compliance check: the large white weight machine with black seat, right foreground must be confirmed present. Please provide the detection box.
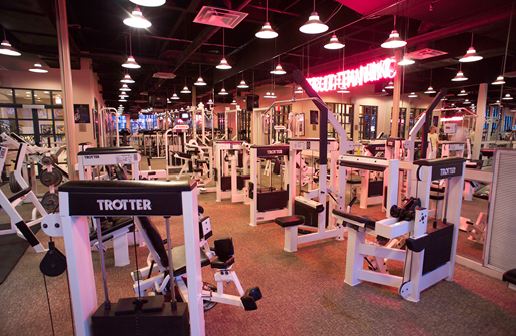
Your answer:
[333,156,465,302]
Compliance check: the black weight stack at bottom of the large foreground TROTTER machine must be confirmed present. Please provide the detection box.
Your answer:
[91,295,190,336]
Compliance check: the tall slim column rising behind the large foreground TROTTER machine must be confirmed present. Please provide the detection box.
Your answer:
[56,0,78,180]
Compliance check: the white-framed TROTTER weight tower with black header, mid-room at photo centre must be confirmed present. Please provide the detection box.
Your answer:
[249,144,289,226]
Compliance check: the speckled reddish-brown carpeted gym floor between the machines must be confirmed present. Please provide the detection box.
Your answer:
[0,194,516,336]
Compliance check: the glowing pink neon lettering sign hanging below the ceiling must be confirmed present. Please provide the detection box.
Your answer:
[307,58,396,92]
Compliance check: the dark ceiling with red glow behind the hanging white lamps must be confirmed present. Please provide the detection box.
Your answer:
[0,0,516,105]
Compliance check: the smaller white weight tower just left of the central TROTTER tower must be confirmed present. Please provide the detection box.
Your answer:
[214,141,249,203]
